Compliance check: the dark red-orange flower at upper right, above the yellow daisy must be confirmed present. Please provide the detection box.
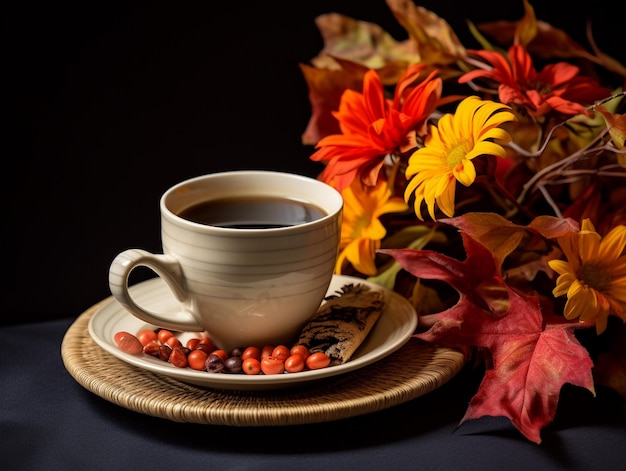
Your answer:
[459,44,611,117]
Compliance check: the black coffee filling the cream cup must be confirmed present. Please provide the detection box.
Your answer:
[178,196,326,229]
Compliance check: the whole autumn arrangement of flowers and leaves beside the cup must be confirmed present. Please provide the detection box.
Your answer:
[301,0,626,443]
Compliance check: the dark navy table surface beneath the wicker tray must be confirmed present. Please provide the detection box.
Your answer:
[0,318,626,471]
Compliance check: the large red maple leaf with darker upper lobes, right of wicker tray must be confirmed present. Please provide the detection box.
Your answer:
[381,225,595,443]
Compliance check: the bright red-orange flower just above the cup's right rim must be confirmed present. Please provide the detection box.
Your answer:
[311,64,442,191]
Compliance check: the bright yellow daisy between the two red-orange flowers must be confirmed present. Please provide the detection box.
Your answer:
[404,96,515,220]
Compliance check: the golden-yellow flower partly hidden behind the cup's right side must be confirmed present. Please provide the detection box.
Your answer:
[335,178,408,275]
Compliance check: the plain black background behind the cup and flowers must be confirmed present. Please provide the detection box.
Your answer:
[6,0,626,323]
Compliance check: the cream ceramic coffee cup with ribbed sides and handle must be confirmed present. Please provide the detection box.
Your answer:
[109,170,343,351]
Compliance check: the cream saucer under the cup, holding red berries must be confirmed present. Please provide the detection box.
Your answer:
[88,276,417,390]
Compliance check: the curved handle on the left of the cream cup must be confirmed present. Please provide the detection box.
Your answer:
[109,249,203,331]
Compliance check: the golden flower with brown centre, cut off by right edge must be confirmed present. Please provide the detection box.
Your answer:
[548,219,626,334]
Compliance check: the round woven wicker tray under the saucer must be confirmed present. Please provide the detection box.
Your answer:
[61,305,464,426]
